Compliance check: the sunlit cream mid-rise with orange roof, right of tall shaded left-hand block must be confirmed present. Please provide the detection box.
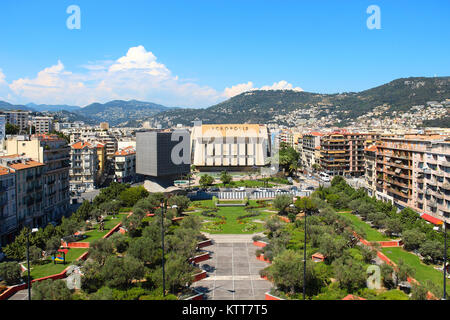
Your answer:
[69,141,98,191]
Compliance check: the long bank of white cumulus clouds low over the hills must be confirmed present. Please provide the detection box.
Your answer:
[0,46,302,107]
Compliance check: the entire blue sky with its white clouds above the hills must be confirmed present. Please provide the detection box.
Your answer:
[0,0,450,107]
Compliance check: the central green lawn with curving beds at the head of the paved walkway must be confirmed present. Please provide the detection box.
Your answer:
[189,200,273,234]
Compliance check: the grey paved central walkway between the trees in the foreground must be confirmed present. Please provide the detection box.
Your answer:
[192,234,272,300]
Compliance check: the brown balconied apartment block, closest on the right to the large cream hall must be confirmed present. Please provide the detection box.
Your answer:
[320,130,379,177]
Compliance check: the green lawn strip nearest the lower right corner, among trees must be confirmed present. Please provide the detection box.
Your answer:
[381,248,450,287]
